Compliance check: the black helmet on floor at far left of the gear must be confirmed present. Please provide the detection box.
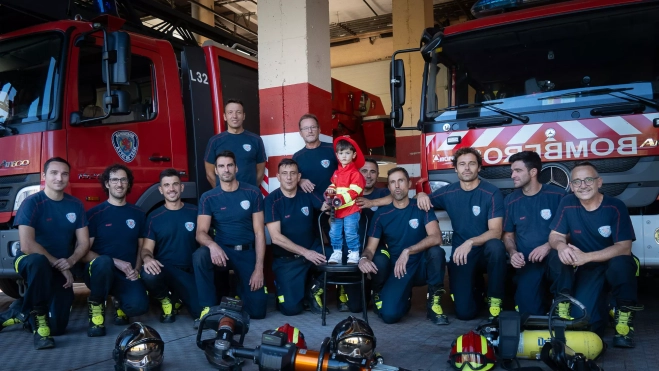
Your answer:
[112,322,165,371]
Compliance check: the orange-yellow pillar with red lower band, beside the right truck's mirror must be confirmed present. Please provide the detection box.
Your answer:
[392,0,434,182]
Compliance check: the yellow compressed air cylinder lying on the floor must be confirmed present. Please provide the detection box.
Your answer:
[517,330,604,359]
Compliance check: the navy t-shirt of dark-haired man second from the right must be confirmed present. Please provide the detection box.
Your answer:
[503,184,565,258]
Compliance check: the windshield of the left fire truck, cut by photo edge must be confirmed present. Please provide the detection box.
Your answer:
[0,33,63,136]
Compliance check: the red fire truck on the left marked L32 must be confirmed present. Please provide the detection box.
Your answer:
[0,0,395,297]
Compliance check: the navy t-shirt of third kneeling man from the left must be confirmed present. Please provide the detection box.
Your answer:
[146,203,199,267]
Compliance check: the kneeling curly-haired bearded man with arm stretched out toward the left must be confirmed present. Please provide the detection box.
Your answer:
[417,147,506,320]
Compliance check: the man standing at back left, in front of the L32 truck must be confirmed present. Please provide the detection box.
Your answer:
[205,99,268,188]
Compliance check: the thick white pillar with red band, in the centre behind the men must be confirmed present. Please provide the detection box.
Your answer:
[258,0,332,193]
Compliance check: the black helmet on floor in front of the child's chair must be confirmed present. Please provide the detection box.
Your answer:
[331,316,375,365]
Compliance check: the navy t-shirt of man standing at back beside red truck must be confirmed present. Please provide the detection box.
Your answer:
[205,130,268,186]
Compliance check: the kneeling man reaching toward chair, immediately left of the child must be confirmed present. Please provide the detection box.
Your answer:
[265,159,329,316]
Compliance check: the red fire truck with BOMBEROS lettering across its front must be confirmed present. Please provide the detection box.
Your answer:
[391,0,659,269]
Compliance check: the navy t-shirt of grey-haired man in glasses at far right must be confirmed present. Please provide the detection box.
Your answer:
[549,194,636,252]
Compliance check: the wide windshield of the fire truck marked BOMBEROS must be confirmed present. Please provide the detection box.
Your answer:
[424,6,659,130]
